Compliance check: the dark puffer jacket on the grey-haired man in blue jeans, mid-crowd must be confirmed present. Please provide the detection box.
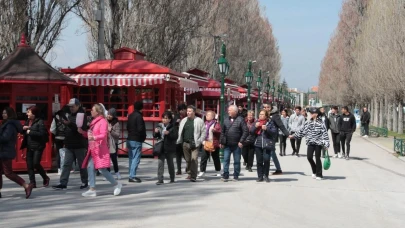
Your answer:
[220,116,249,147]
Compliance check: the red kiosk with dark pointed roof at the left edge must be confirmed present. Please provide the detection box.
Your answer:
[0,35,76,171]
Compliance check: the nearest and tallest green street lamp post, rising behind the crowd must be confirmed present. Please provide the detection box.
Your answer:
[218,43,229,162]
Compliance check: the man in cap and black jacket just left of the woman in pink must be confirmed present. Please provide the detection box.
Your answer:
[52,98,88,190]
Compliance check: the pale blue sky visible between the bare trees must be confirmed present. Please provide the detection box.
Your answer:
[47,0,342,91]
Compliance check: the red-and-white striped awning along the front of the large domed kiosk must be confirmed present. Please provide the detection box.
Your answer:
[67,74,170,86]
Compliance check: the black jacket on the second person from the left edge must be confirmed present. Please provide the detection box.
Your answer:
[20,119,48,151]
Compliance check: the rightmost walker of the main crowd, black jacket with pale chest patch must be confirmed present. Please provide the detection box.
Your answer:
[338,106,356,160]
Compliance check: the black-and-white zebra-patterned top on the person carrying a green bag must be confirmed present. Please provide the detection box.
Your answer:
[294,118,329,148]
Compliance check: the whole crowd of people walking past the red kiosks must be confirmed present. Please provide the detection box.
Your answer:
[0,98,369,198]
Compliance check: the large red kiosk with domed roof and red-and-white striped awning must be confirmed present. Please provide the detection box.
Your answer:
[62,47,198,154]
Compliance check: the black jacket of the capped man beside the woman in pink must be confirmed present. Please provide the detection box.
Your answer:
[63,108,88,149]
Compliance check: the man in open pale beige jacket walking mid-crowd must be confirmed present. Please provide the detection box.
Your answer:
[177,105,206,182]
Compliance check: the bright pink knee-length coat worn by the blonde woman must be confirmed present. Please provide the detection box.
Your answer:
[82,116,110,169]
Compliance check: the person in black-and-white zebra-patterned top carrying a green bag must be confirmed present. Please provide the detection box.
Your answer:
[293,108,329,180]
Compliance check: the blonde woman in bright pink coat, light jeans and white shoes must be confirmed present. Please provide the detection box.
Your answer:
[78,104,122,197]
